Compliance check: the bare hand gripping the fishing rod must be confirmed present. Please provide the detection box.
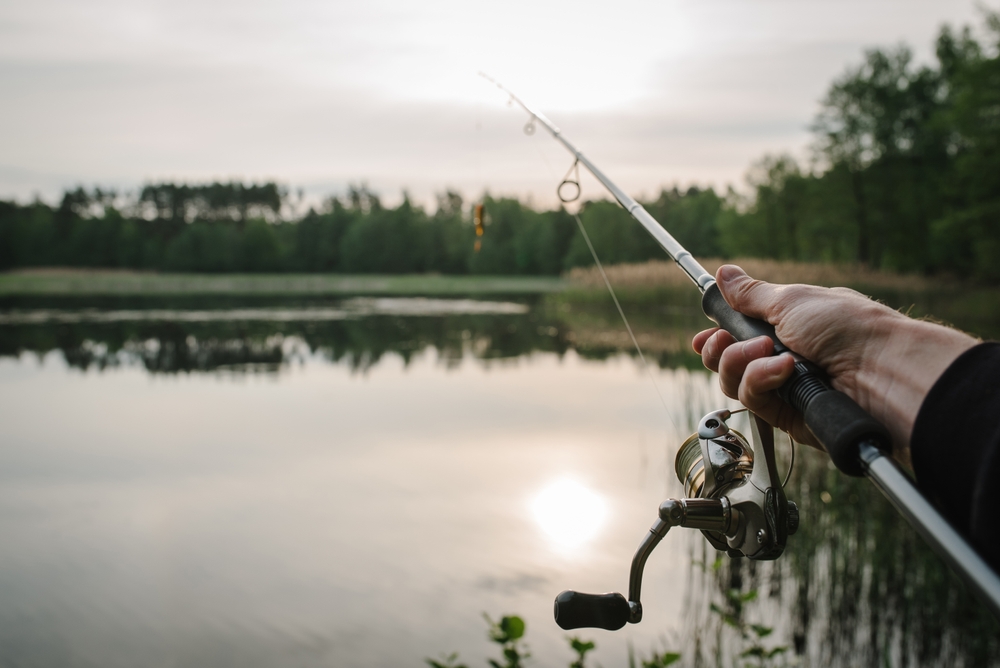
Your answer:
[692,265,976,461]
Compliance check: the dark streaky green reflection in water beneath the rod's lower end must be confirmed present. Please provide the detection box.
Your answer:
[687,451,1000,666]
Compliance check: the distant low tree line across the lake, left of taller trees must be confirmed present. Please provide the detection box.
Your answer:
[0,183,722,275]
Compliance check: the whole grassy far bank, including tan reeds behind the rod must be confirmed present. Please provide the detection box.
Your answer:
[7,259,1000,342]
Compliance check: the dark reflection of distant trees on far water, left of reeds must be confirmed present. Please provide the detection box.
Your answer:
[0,304,580,373]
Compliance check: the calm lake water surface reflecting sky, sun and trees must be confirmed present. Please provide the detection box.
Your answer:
[0,299,998,667]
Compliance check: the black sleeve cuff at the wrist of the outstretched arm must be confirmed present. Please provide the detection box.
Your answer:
[910,343,1000,572]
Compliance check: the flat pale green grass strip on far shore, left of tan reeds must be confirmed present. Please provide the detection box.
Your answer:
[0,269,567,297]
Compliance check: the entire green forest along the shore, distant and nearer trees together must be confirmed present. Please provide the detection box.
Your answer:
[0,13,1000,283]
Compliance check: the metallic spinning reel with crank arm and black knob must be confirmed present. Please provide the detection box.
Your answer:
[555,409,799,631]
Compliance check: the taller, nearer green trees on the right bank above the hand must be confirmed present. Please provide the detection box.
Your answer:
[719,13,1000,282]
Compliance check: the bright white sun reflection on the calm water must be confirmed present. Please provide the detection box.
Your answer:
[531,479,608,549]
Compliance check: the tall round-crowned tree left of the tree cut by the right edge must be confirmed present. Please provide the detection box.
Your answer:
[814,46,949,271]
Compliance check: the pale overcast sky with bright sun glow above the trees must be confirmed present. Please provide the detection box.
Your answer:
[0,0,1000,207]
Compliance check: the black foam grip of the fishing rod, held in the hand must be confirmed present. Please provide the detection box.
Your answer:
[701,283,891,477]
